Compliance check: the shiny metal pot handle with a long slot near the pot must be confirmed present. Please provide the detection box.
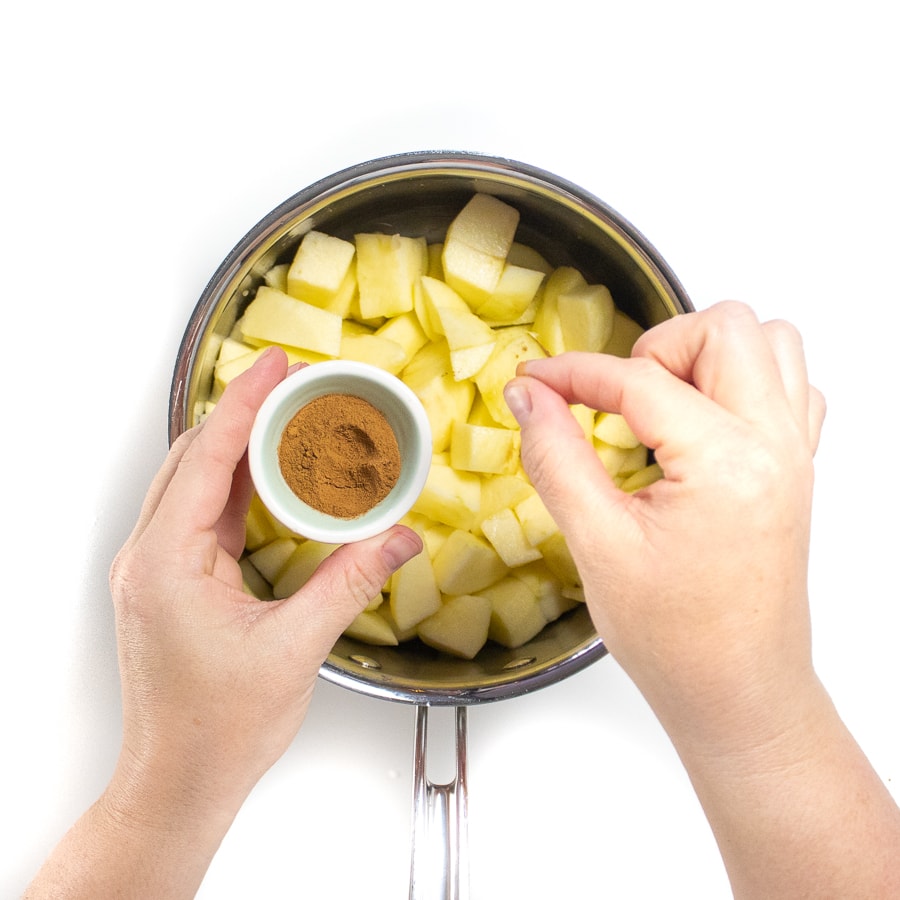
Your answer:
[409,706,469,900]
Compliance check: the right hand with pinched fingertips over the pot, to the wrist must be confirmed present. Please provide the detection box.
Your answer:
[507,303,825,742]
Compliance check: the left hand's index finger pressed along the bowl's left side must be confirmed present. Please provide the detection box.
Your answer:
[157,347,287,549]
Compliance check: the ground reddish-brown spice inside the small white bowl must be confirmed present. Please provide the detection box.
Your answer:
[278,394,400,519]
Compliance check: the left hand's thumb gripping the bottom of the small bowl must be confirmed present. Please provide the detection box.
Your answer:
[282,525,422,659]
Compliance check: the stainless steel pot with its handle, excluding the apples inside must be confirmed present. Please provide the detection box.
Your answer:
[169,152,692,900]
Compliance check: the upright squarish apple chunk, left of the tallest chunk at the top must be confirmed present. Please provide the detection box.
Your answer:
[355,233,428,320]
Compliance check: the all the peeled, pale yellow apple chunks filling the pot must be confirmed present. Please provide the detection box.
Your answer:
[222,193,663,659]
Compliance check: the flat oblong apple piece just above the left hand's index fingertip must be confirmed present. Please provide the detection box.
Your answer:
[241,285,341,356]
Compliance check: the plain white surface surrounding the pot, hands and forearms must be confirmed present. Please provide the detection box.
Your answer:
[0,0,900,900]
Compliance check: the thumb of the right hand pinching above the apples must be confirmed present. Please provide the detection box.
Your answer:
[504,376,621,539]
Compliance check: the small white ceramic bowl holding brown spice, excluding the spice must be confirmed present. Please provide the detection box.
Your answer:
[247,360,432,544]
